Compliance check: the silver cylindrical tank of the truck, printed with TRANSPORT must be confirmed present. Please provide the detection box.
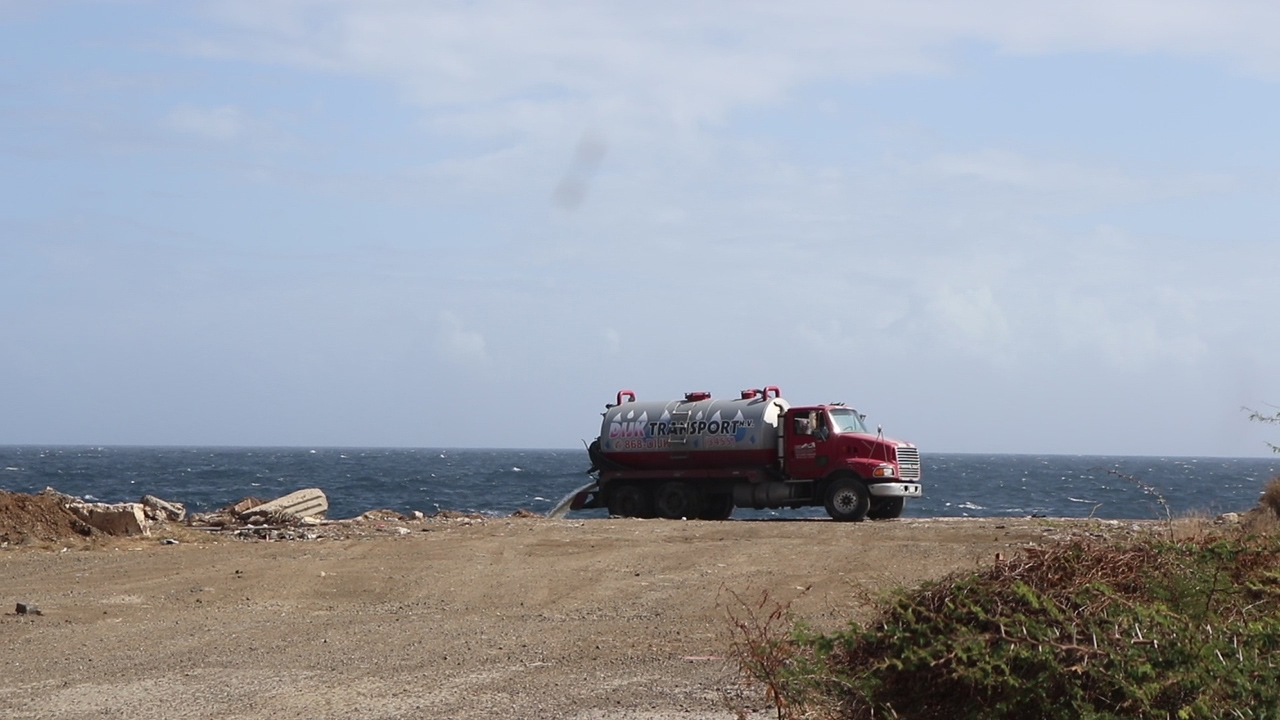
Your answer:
[600,386,790,470]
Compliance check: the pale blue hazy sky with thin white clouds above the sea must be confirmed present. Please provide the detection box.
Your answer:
[0,0,1280,456]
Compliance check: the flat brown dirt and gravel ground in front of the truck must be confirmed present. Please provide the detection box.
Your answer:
[0,509,1151,720]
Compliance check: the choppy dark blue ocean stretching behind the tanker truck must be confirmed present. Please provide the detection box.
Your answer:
[0,446,1280,519]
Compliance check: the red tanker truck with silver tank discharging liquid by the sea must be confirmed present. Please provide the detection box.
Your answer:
[571,386,922,520]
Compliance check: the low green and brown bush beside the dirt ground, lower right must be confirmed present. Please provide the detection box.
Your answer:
[756,537,1280,720]
